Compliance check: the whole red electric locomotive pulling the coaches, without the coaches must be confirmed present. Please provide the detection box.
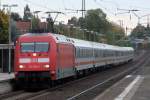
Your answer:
[15,33,75,86]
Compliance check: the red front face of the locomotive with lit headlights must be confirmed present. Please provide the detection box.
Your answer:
[15,35,55,82]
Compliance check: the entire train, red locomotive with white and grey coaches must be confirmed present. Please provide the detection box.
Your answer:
[14,33,134,86]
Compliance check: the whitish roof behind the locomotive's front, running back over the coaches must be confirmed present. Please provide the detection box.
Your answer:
[53,34,134,51]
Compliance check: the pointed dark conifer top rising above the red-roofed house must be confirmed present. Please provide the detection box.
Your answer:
[23,5,32,21]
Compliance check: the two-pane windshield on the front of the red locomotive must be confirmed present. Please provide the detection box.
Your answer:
[21,42,49,52]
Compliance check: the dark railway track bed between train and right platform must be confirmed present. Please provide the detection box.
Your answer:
[0,50,149,100]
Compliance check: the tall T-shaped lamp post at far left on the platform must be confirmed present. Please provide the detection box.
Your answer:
[3,4,18,74]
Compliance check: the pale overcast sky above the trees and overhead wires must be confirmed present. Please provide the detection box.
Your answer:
[0,0,150,33]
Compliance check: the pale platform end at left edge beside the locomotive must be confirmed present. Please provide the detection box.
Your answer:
[0,73,15,82]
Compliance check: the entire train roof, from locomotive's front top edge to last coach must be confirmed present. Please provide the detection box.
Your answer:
[21,33,134,51]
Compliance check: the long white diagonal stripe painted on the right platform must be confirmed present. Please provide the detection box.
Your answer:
[114,75,141,100]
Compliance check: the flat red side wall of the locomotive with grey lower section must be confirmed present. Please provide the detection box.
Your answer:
[58,43,75,78]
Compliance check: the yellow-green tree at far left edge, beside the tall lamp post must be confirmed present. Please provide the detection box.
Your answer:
[0,11,8,43]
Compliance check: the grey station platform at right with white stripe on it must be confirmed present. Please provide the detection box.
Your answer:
[94,71,150,100]
